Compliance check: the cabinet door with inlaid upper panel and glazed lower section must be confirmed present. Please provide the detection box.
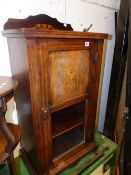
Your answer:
[43,40,100,161]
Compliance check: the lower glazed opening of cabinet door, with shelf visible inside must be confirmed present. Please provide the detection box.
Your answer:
[51,101,85,158]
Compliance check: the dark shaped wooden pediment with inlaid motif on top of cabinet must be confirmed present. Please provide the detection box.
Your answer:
[4,14,73,31]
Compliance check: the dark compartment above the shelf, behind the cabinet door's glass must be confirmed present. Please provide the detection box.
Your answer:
[51,101,85,139]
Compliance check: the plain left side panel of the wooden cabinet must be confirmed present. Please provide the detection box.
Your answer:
[8,38,35,168]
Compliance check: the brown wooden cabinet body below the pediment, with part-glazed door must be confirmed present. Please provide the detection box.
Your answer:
[3,15,108,175]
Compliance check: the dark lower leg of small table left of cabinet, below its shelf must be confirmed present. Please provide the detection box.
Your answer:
[7,152,17,175]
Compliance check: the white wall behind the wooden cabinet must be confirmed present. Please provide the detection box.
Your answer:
[0,0,119,131]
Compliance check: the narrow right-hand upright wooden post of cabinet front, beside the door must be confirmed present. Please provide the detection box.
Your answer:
[86,40,103,142]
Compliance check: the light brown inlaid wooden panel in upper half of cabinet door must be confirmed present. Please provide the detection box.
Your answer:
[49,49,90,106]
